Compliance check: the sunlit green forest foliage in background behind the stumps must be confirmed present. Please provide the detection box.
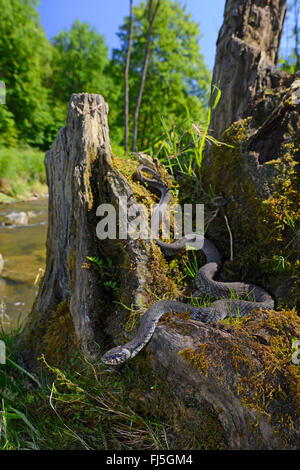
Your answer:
[0,0,210,150]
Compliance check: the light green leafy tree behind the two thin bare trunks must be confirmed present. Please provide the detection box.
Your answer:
[112,0,210,149]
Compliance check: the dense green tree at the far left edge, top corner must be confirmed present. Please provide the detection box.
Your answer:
[0,0,54,146]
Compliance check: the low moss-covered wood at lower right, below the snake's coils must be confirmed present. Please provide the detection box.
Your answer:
[149,311,300,450]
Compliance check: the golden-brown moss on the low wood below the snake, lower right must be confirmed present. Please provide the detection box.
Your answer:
[179,310,300,443]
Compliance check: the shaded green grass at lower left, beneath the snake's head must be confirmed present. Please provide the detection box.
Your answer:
[0,322,168,450]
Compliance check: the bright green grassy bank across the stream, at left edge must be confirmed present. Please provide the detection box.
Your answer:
[0,147,46,198]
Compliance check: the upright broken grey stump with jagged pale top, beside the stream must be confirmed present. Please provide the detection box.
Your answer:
[22,93,154,359]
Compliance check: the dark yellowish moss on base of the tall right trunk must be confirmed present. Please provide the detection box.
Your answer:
[198,112,300,309]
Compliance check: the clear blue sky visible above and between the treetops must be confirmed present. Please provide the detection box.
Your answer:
[39,0,225,70]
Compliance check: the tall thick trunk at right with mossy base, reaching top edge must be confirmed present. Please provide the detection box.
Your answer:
[201,0,300,314]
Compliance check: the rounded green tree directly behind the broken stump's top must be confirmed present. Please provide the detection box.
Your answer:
[51,20,124,147]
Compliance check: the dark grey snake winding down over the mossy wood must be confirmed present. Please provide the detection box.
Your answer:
[101,165,274,365]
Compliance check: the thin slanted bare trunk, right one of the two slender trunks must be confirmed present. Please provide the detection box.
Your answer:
[132,0,160,152]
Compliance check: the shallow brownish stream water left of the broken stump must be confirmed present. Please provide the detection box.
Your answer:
[0,198,48,328]
